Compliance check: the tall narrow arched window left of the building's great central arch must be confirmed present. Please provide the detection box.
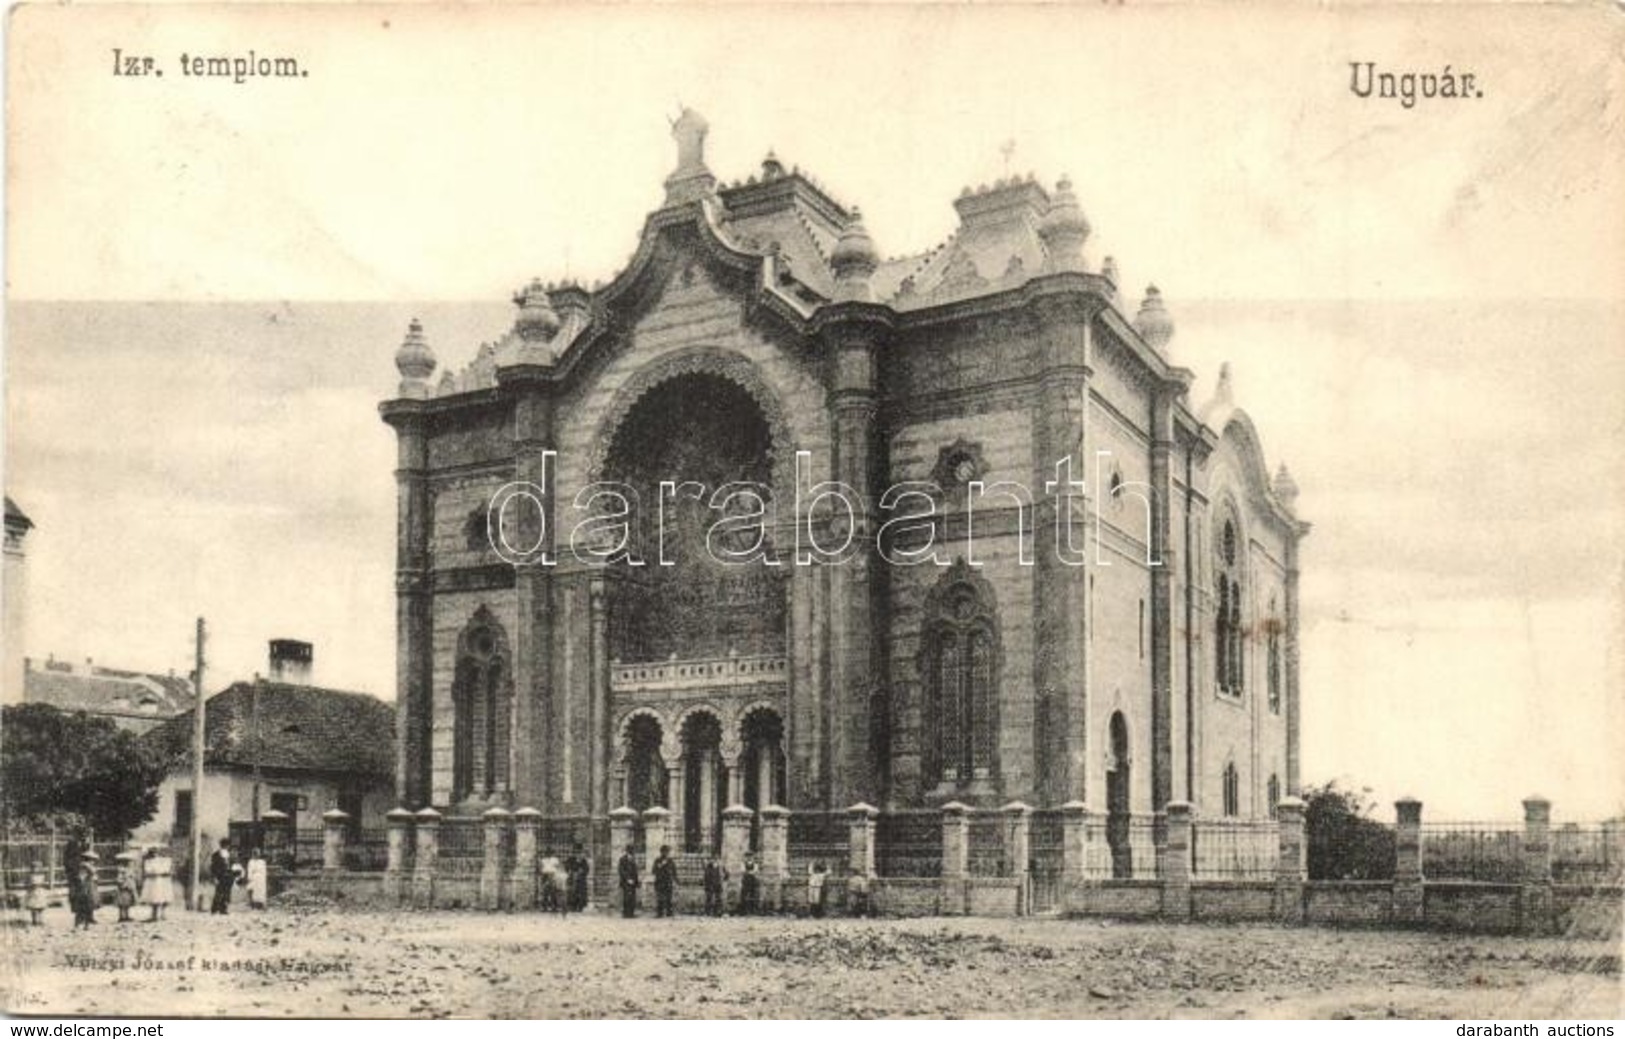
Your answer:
[452,606,514,802]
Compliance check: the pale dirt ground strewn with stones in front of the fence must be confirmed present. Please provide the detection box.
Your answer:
[0,907,1625,1019]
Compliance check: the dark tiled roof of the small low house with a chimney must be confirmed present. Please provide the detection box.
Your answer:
[146,681,395,777]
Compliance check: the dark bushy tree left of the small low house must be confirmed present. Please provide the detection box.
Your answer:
[0,704,166,837]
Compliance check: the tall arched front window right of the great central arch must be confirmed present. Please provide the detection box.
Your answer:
[920,563,998,787]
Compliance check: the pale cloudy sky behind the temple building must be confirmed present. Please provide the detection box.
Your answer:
[5,5,1625,819]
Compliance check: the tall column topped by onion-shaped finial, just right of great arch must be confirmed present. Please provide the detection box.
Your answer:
[825,299,892,805]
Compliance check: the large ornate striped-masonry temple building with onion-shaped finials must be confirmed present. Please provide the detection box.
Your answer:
[382,112,1308,849]
